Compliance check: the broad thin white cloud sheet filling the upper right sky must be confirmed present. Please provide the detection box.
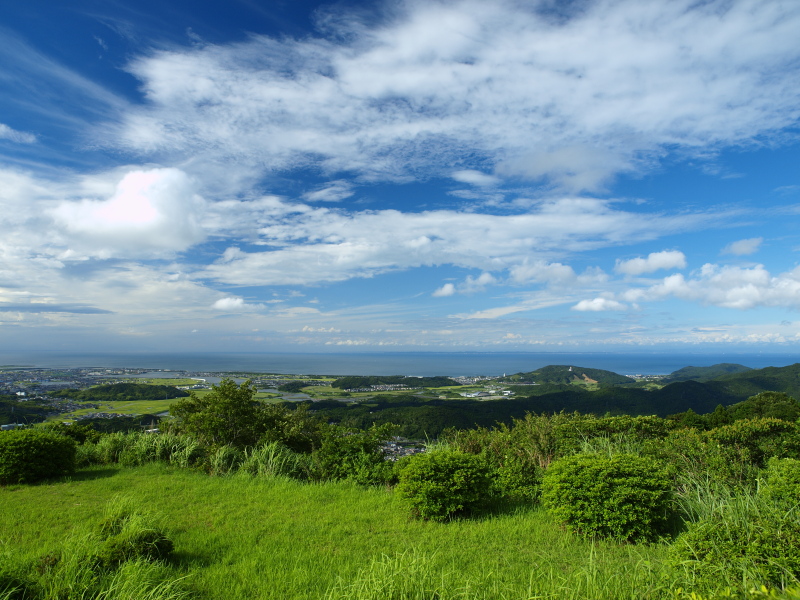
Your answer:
[111,0,800,190]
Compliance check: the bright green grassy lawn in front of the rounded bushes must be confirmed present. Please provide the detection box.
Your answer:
[0,464,671,600]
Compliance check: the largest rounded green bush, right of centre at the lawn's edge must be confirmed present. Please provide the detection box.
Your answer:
[542,454,672,541]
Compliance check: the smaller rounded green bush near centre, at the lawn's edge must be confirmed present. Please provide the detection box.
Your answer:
[396,449,494,521]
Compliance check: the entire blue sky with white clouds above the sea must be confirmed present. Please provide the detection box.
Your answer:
[0,0,800,352]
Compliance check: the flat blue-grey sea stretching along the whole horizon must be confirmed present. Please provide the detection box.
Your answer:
[0,352,800,376]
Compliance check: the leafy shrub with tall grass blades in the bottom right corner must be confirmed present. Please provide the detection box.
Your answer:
[669,493,800,589]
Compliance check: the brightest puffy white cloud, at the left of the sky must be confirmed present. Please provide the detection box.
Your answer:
[52,168,204,257]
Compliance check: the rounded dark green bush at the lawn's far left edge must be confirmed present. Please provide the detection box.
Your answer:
[0,429,75,484]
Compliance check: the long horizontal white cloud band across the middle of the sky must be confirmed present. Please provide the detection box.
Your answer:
[205,197,727,285]
